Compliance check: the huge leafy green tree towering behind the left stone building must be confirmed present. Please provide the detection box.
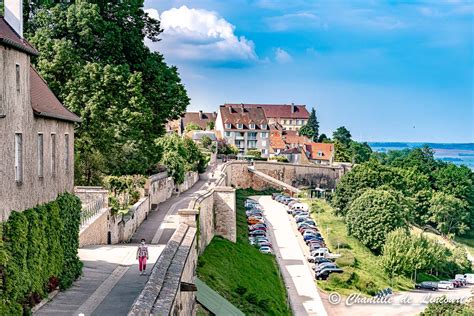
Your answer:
[28,0,189,184]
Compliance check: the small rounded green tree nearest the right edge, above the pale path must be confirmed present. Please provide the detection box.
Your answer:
[429,192,470,235]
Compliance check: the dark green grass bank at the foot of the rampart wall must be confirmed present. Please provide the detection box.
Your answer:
[197,189,291,315]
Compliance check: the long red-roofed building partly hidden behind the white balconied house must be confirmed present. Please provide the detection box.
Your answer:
[224,104,309,131]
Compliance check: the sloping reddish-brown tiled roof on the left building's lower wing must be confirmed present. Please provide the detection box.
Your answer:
[30,66,81,122]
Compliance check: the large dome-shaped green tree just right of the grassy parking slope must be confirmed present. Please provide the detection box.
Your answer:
[346,189,408,252]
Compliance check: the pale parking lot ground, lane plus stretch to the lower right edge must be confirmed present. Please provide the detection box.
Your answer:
[253,196,474,316]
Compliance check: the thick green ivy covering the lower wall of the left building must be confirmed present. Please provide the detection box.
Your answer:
[0,193,82,315]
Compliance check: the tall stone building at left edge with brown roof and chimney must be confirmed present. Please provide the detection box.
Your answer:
[0,4,80,221]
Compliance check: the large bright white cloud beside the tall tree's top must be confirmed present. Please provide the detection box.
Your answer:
[145,6,258,64]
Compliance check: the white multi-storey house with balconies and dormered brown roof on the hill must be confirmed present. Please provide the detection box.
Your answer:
[215,105,270,157]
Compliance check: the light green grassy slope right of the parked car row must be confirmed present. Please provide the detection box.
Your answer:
[312,200,413,295]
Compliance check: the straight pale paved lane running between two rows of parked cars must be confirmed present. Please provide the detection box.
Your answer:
[253,196,327,315]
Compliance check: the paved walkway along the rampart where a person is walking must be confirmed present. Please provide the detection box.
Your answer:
[35,172,217,316]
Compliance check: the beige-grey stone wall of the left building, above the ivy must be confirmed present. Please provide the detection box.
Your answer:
[0,45,74,221]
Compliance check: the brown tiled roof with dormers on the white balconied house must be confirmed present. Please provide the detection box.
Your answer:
[219,105,268,130]
